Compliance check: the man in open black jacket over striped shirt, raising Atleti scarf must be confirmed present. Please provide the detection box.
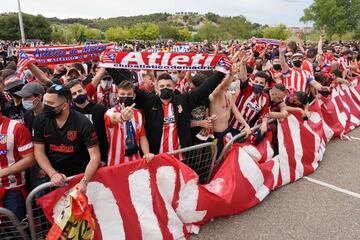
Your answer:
[135,61,231,154]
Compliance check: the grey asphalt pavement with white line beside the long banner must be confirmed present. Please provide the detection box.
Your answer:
[190,128,360,240]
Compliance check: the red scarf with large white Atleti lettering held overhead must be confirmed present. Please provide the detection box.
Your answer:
[99,49,228,71]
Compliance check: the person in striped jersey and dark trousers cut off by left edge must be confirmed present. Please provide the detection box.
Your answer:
[0,102,35,221]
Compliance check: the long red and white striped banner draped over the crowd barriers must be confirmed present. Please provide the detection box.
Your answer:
[38,80,360,239]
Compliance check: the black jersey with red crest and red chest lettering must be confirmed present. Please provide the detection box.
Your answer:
[33,110,98,176]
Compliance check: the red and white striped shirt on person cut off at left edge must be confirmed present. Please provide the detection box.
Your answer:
[0,116,33,189]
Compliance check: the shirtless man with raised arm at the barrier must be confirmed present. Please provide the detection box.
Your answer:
[209,73,251,154]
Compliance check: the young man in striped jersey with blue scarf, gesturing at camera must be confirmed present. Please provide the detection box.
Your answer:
[105,81,154,166]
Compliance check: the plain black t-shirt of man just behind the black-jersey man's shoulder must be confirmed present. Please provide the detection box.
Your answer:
[73,102,109,162]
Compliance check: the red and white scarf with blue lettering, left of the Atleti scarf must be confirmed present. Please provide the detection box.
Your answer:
[19,43,114,65]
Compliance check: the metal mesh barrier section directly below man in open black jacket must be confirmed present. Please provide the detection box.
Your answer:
[168,142,217,184]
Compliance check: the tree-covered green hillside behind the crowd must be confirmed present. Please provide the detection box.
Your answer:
[0,12,298,43]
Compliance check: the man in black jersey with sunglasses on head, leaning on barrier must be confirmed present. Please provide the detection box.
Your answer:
[33,85,100,192]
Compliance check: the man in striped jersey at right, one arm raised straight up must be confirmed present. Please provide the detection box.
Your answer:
[279,42,324,93]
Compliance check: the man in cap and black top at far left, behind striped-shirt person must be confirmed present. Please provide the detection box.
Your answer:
[4,75,25,122]
